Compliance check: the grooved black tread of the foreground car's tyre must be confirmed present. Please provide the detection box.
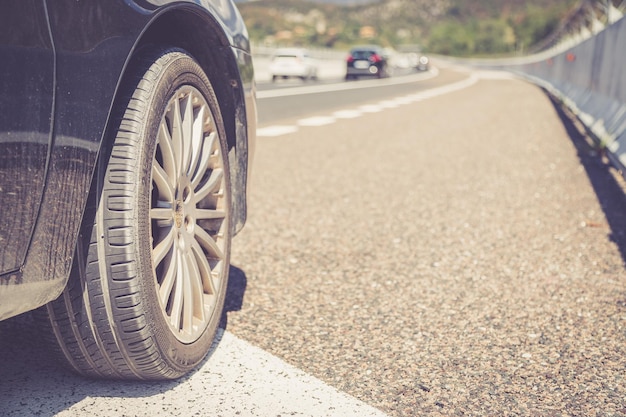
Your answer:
[41,50,228,379]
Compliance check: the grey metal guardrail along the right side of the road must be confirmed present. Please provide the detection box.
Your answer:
[504,14,626,175]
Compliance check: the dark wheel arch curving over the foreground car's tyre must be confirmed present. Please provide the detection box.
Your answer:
[98,5,250,232]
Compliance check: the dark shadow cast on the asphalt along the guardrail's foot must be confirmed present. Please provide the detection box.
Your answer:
[550,96,626,267]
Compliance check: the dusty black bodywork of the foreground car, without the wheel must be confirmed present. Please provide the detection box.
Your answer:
[0,0,256,319]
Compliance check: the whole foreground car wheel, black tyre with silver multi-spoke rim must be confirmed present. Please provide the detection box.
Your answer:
[38,49,231,380]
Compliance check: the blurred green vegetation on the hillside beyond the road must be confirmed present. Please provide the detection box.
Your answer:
[239,0,577,56]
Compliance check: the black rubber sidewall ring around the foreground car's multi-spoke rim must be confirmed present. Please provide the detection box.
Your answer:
[122,50,232,374]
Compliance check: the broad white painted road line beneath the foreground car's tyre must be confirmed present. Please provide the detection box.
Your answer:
[56,330,386,417]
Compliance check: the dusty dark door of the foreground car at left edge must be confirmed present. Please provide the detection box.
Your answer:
[0,0,54,275]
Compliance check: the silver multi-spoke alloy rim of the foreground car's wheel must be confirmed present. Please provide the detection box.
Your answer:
[150,86,229,343]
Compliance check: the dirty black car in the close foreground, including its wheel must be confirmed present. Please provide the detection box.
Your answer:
[0,0,256,379]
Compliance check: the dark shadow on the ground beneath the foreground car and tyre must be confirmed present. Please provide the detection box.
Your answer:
[0,266,247,417]
